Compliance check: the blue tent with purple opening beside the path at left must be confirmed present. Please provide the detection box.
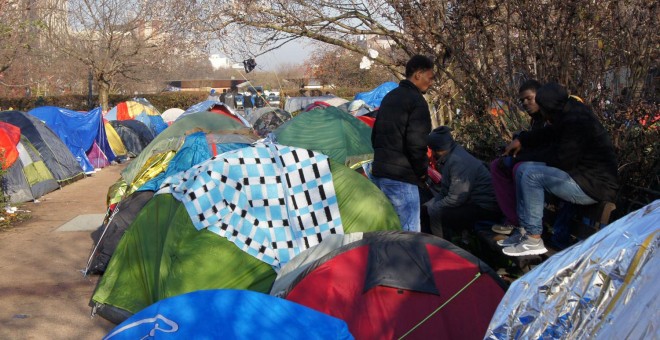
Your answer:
[28,106,115,173]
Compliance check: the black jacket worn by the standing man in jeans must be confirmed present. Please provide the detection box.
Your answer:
[371,80,431,184]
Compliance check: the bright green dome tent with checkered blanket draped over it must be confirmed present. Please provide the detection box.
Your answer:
[87,147,400,322]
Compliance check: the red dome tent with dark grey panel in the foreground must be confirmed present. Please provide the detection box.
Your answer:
[272,232,505,339]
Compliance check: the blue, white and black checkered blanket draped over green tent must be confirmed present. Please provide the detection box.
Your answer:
[157,143,343,270]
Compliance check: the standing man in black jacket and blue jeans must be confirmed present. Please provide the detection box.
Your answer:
[371,55,435,231]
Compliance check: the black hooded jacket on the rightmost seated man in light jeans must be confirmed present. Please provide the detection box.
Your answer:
[518,83,619,202]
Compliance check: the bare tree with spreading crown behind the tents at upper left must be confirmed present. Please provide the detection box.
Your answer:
[44,0,205,110]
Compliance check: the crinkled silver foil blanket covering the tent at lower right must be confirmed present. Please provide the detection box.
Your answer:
[485,200,660,339]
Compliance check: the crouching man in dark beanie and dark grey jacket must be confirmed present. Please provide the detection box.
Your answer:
[423,126,501,239]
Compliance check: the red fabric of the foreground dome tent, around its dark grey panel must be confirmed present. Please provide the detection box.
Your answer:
[286,245,504,339]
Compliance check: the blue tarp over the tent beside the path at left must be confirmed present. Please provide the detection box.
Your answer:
[28,106,102,173]
